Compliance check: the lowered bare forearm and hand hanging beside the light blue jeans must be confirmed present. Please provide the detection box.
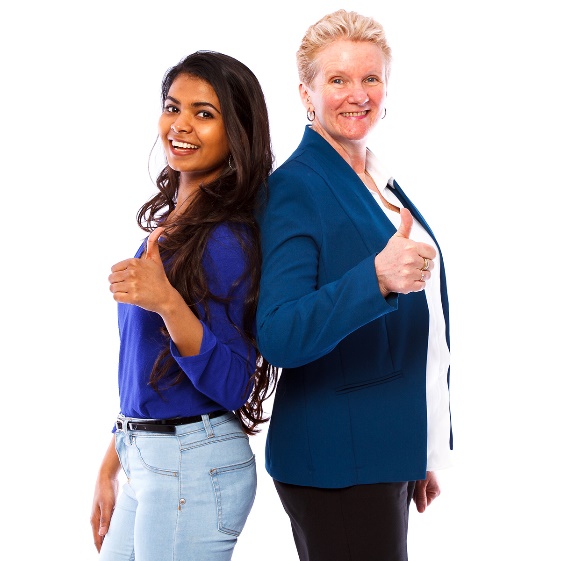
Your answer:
[90,435,121,552]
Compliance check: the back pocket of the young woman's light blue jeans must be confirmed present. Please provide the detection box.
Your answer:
[210,455,257,536]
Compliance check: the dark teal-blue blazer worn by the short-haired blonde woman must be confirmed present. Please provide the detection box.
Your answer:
[257,127,452,488]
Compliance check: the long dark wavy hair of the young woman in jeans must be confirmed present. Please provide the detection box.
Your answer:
[137,51,278,434]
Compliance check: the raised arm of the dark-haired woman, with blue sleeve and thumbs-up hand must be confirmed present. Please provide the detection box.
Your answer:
[109,225,256,410]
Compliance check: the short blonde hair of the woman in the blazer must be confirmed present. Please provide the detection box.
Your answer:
[296,10,392,85]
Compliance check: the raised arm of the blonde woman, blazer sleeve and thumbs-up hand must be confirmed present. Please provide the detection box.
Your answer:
[257,170,434,368]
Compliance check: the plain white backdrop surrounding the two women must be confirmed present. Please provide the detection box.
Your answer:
[0,0,561,561]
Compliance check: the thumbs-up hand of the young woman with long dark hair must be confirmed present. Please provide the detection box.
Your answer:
[109,226,181,315]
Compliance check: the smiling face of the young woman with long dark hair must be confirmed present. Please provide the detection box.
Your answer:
[158,74,230,185]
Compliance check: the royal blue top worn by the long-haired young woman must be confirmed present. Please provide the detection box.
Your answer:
[118,224,256,419]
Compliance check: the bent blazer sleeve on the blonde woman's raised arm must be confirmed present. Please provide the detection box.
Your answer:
[257,162,397,368]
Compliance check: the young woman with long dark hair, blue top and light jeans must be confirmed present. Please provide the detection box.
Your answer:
[91,51,277,561]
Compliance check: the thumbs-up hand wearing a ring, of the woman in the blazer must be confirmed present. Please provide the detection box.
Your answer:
[374,208,436,298]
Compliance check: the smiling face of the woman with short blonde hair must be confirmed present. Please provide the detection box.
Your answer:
[300,39,386,147]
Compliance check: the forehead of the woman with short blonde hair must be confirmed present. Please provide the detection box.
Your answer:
[316,39,386,77]
